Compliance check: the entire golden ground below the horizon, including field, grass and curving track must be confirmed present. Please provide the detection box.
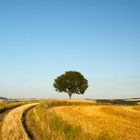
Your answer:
[0,99,140,140]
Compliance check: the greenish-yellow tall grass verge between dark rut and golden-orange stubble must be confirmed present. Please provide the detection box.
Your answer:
[26,101,92,140]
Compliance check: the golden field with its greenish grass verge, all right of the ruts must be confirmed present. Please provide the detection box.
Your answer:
[26,100,140,140]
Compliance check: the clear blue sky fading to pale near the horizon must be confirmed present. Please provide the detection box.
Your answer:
[0,0,140,98]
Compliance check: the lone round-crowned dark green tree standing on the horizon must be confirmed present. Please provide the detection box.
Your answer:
[53,71,88,99]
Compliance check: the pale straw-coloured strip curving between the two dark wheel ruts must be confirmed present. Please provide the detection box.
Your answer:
[2,103,38,140]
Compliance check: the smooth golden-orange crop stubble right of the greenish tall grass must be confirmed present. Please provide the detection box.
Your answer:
[54,105,140,140]
